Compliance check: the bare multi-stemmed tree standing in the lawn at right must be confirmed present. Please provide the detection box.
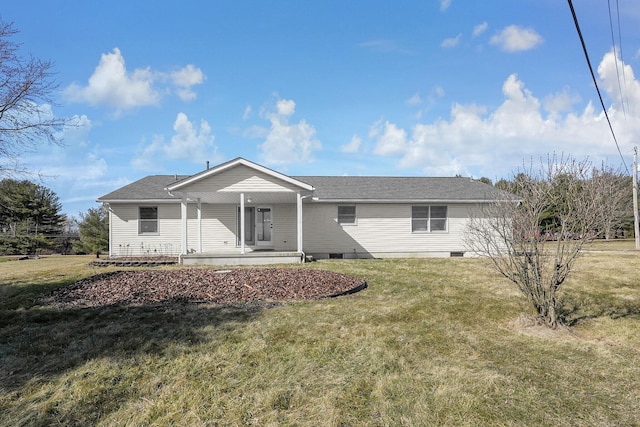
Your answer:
[467,155,624,328]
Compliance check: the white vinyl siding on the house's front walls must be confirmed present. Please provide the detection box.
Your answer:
[110,202,482,257]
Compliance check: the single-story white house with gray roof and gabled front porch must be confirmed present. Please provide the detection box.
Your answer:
[98,158,499,264]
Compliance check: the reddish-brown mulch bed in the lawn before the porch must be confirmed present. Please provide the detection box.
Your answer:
[46,268,367,308]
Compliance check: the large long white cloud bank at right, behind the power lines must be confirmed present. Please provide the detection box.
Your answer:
[369,52,640,178]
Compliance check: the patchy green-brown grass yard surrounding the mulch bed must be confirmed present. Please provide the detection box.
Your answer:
[0,252,640,426]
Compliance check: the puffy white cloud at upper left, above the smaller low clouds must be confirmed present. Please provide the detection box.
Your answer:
[64,47,205,115]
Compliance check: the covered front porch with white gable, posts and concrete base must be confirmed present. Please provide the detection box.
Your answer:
[167,159,313,265]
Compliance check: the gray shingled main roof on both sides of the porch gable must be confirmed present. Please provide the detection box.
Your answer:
[98,175,504,202]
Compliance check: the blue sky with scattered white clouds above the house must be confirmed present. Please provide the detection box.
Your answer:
[0,0,640,216]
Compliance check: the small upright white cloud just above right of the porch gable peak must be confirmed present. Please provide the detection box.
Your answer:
[259,99,322,165]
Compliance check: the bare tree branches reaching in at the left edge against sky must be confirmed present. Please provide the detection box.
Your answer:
[0,20,67,175]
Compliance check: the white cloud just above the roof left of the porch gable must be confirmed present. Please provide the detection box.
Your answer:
[132,113,221,170]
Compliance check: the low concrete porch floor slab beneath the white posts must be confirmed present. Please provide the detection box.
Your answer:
[181,251,304,265]
